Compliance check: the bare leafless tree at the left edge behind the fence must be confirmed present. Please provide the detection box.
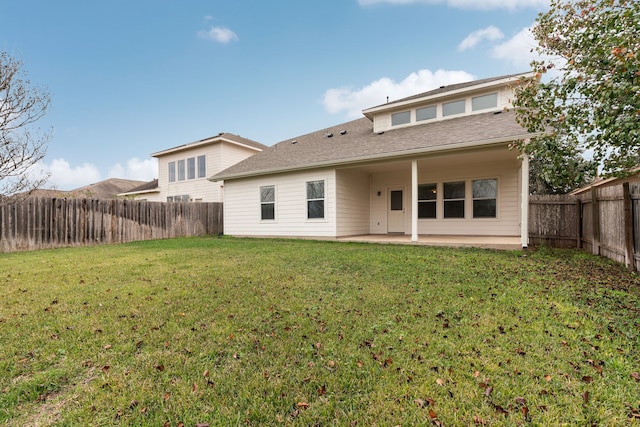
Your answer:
[0,52,51,204]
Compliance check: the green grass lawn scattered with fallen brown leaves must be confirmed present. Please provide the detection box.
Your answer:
[0,237,640,426]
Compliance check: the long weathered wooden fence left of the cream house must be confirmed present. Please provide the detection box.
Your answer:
[0,197,223,252]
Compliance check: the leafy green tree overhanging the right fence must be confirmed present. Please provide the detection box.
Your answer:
[514,0,640,189]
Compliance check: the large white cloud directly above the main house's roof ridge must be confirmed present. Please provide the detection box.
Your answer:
[322,70,474,118]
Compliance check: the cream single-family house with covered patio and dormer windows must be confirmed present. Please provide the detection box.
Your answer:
[209,73,534,247]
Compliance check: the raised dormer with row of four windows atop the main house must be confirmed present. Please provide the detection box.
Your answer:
[363,73,533,133]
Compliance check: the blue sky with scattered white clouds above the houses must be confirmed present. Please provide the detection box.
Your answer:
[0,0,549,190]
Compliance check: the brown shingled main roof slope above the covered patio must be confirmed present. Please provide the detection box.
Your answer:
[209,111,530,181]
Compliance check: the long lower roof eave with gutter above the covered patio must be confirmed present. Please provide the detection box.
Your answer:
[207,133,532,182]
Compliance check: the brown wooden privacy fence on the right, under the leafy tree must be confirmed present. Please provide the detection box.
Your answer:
[529,182,640,270]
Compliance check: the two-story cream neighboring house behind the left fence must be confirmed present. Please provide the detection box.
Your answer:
[119,133,267,202]
